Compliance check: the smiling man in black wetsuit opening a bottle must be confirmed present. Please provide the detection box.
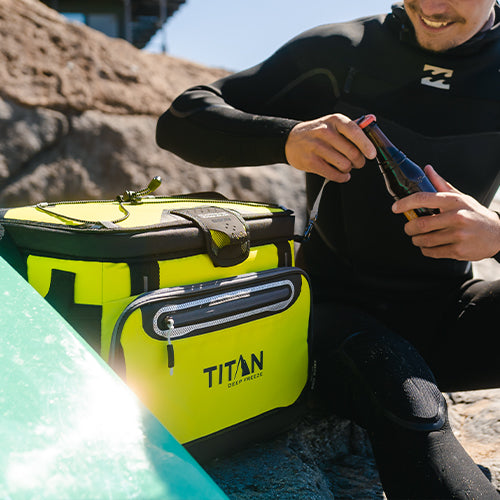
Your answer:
[157,0,500,499]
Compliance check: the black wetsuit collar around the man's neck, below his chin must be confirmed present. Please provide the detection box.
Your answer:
[386,2,500,55]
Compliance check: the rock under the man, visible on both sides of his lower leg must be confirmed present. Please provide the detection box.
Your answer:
[205,389,500,500]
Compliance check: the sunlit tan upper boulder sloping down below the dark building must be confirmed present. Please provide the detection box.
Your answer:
[0,0,227,116]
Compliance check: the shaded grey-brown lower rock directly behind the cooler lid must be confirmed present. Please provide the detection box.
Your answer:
[0,99,304,230]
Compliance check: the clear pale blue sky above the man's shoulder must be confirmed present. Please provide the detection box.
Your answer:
[147,0,393,71]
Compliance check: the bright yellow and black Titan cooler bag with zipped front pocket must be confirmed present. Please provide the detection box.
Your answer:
[0,179,311,459]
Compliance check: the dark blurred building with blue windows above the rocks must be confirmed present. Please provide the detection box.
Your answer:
[42,0,187,50]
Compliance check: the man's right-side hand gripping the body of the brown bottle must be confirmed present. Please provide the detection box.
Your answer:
[392,165,500,261]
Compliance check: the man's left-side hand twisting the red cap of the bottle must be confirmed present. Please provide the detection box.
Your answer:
[285,114,376,183]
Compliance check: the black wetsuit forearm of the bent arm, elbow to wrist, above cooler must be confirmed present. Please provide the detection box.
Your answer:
[156,82,297,167]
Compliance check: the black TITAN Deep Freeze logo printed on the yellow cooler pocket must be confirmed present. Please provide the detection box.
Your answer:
[203,351,264,388]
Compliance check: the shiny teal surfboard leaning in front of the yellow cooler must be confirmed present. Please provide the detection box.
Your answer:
[0,257,227,500]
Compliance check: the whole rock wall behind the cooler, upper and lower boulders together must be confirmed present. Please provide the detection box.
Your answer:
[0,0,303,229]
